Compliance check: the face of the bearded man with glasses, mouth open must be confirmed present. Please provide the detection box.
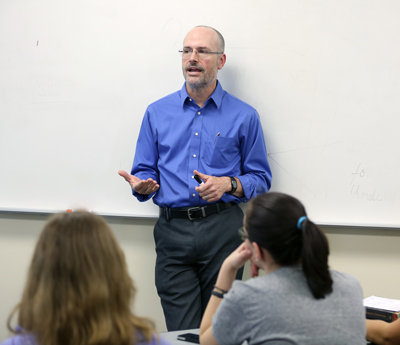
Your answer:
[182,27,225,89]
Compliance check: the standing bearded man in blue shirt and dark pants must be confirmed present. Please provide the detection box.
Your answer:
[119,26,271,331]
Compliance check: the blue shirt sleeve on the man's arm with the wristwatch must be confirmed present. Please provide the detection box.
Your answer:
[236,110,272,202]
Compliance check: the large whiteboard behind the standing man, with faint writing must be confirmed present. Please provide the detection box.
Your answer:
[0,0,400,227]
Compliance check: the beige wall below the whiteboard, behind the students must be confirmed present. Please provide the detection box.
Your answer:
[0,213,400,341]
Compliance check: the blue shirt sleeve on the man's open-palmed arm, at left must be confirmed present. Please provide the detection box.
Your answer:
[131,108,160,201]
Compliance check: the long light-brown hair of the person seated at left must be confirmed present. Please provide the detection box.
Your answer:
[8,211,154,345]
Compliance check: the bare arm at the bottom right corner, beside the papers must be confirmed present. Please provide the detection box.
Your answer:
[366,319,400,345]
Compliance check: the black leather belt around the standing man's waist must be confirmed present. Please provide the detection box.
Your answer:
[160,202,236,220]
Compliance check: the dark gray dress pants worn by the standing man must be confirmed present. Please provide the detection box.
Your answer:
[154,205,243,331]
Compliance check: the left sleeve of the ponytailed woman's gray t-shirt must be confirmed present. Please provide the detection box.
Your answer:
[212,282,249,345]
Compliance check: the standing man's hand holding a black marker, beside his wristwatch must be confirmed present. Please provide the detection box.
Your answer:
[193,170,231,202]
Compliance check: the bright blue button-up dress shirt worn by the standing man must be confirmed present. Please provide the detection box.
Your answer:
[131,82,272,207]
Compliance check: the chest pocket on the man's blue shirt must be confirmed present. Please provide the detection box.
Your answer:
[204,137,240,168]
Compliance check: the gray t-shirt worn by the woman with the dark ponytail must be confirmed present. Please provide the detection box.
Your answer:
[212,265,366,345]
